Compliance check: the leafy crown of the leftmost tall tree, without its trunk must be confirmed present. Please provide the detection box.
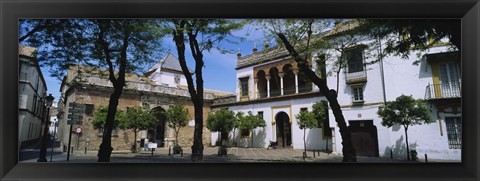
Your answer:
[19,19,164,80]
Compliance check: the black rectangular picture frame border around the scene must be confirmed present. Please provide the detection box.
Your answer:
[0,0,480,180]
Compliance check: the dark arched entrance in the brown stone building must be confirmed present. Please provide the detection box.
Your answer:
[148,106,167,147]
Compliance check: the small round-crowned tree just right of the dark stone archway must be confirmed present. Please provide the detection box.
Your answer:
[165,105,189,146]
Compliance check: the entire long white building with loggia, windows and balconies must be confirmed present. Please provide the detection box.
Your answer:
[212,23,462,160]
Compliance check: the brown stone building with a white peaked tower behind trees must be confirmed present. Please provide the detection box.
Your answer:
[58,53,228,150]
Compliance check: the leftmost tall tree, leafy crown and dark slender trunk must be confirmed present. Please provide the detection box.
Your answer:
[21,19,162,162]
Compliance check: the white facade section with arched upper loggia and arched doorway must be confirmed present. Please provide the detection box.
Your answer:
[212,46,331,150]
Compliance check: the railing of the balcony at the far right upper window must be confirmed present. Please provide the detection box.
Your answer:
[425,83,462,99]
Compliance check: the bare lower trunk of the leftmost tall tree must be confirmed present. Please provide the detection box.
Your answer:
[97,86,123,162]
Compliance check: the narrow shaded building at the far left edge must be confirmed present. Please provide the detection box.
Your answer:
[18,45,47,148]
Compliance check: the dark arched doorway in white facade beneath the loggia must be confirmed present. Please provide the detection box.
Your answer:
[275,111,292,147]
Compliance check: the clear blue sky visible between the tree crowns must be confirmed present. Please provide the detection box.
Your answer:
[41,23,263,101]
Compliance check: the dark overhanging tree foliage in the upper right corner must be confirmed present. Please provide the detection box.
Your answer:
[353,19,462,57]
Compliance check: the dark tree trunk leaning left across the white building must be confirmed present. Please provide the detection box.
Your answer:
[277,33,357,162]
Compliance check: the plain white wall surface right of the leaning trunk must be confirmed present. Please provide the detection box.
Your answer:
[327,43,461,160]
